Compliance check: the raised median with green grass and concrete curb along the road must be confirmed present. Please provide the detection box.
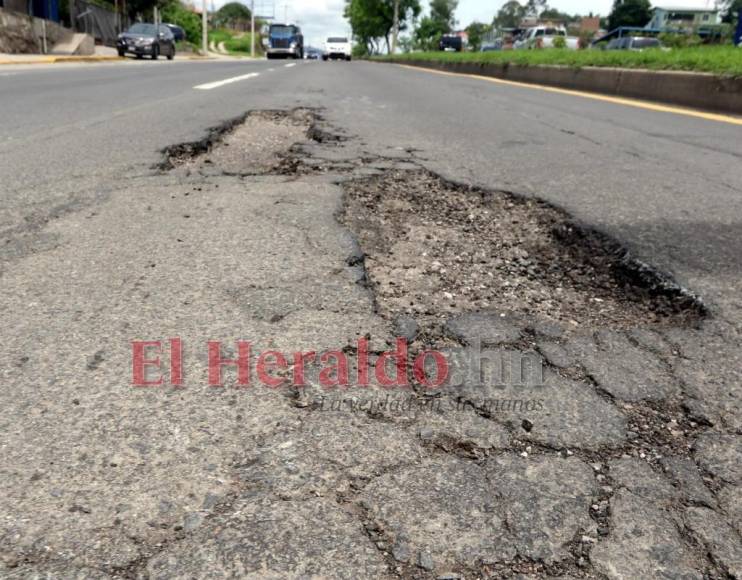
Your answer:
[372,47,742,115]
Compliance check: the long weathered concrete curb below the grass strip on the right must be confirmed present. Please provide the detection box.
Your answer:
[384,59,742,115]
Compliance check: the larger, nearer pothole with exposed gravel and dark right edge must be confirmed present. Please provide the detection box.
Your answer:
[341,171,705,328]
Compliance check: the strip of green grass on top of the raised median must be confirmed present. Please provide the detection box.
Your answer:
[374,46,742,77]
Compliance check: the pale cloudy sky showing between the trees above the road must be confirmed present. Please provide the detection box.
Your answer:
[244,0,713,47]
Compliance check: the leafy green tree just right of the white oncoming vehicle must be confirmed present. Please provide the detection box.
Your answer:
[345,0,421,53]
